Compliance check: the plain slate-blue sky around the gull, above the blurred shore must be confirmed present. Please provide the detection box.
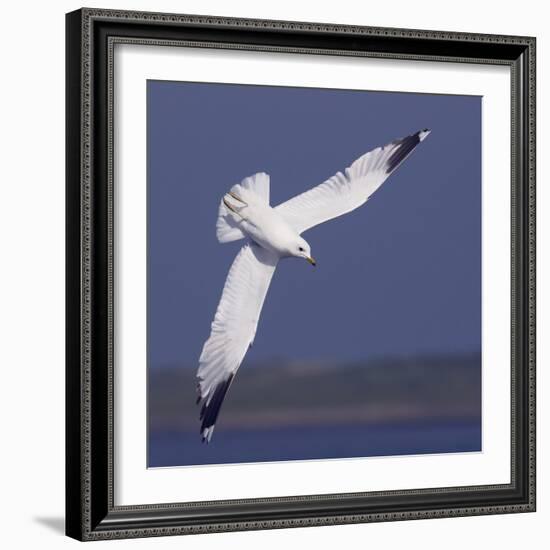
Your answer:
[147,81,481,368]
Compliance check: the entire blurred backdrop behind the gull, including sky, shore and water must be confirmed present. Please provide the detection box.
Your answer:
[147,81,481,467]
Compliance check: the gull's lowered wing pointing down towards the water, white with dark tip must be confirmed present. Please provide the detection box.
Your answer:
[197,243,279,442]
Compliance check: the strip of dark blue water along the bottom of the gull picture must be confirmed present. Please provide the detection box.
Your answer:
[148,420,481,467]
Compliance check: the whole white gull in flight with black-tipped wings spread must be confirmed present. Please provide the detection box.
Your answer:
[197,129,430,443]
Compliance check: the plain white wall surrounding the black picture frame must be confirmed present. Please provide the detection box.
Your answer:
[0,0,550,550]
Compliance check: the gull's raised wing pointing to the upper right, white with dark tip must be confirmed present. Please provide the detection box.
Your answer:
[275,129,430,233]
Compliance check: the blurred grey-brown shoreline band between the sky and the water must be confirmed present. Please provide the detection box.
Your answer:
[148,353,481,431]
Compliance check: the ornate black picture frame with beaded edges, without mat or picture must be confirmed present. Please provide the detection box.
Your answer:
[66,9,535,540]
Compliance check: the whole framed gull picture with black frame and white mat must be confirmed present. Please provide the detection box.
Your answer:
[66,9,535,540]
